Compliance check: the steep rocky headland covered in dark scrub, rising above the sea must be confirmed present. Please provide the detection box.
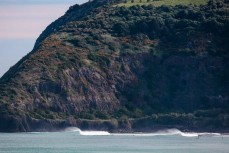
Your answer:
[0,0,229,132]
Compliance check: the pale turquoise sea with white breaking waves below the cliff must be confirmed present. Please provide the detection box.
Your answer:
[0,128,229,153]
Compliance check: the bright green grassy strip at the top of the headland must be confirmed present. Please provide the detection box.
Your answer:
[119,0,208,7]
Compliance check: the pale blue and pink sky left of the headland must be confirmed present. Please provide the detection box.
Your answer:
[0,0,88,77]
